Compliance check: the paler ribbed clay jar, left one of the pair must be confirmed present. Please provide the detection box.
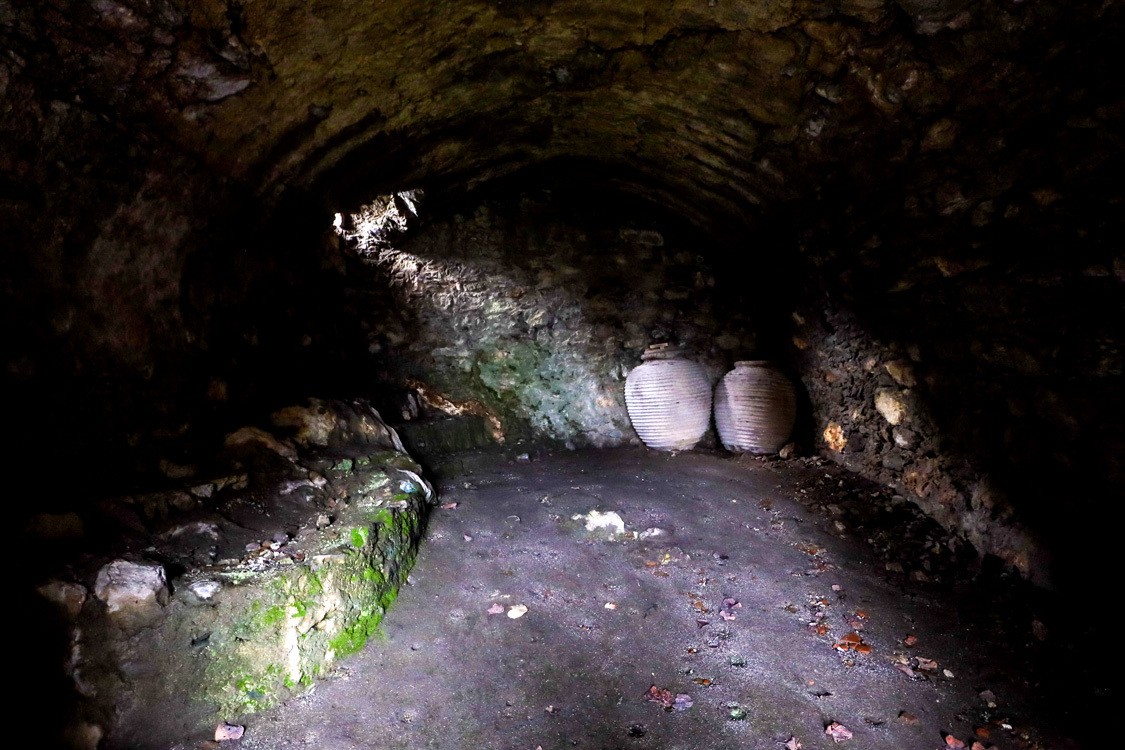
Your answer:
[626,352,711,451]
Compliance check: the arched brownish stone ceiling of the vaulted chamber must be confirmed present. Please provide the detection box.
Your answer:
[10,0,1119,229]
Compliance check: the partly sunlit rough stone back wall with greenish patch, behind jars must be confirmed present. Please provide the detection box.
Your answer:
[346,193,756,446]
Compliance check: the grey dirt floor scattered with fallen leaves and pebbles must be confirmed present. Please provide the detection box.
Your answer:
[189,450,1097,750]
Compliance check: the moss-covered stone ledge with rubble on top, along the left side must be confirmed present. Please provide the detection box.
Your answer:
[30,403,435,749]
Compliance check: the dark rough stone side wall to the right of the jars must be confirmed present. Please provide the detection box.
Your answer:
[791,183,1125,584]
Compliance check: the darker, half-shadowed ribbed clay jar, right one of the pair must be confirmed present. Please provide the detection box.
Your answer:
[714,360,797,453]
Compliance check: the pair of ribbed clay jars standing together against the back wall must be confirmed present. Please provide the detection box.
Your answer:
[626,345,797,454]
